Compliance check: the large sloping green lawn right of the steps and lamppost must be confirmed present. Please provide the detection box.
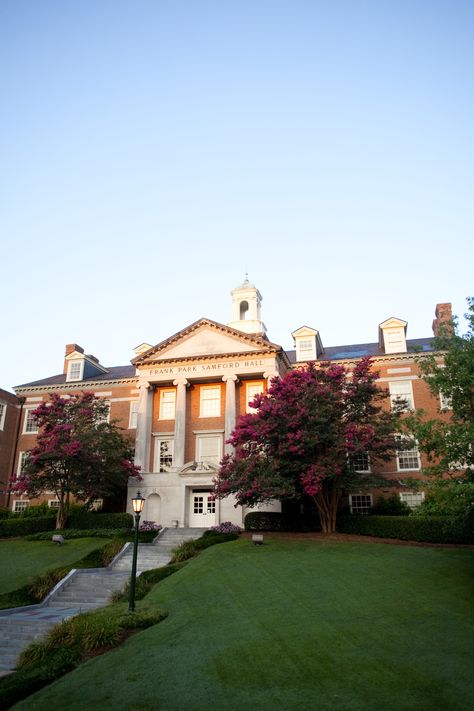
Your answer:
[15,540,474,711]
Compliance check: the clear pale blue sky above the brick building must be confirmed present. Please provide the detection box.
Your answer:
[0,0,474,389]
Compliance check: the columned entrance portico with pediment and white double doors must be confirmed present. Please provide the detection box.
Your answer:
[129,284,290,527]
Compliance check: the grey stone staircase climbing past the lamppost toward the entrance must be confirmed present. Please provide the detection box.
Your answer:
[0,528,206,675]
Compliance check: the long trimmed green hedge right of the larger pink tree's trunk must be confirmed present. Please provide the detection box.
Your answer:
[337,516,474,543]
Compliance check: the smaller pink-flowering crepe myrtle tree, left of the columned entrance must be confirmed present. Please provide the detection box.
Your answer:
[10,392,141,528]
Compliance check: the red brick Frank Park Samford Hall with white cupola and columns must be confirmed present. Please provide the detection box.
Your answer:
[11,280,451,527]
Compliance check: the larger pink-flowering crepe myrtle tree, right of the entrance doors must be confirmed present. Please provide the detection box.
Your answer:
[214,358,402,533]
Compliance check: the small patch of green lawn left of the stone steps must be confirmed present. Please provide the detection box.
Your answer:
[0,532,111,594]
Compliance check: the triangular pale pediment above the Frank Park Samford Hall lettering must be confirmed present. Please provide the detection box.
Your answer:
[132,319,280,365]
